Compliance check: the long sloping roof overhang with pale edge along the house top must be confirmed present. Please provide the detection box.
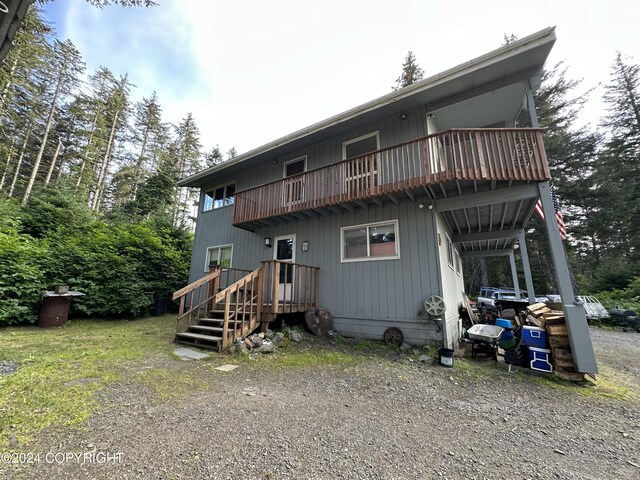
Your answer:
[178,27,556,187]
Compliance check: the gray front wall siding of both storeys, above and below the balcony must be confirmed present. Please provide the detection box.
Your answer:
[190,108,458,344]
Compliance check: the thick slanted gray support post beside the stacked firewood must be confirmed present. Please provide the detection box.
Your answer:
[538,182,598,373]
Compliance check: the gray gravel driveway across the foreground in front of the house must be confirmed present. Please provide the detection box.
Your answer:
[5,329,640,480]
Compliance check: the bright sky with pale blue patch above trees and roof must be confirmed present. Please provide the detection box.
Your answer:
[45,0,640,153]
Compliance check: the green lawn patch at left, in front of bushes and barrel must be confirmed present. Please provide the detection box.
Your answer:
[0,316,175,450]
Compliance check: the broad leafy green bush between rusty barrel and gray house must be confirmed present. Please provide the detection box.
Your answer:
[47,222,188,317]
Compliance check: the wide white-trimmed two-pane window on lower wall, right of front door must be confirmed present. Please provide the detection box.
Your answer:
[340,220,400,263]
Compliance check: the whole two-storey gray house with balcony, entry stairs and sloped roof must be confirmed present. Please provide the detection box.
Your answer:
[174,28,596,373]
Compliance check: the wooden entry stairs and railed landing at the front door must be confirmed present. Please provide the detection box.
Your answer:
[173,260,319,352]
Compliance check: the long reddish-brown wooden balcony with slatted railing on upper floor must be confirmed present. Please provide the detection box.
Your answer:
[232,128,550,230]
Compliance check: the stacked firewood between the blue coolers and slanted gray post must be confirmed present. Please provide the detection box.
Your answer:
[527,303,585,382]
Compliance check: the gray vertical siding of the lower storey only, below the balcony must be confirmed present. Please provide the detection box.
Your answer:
[191,195,442,344]
